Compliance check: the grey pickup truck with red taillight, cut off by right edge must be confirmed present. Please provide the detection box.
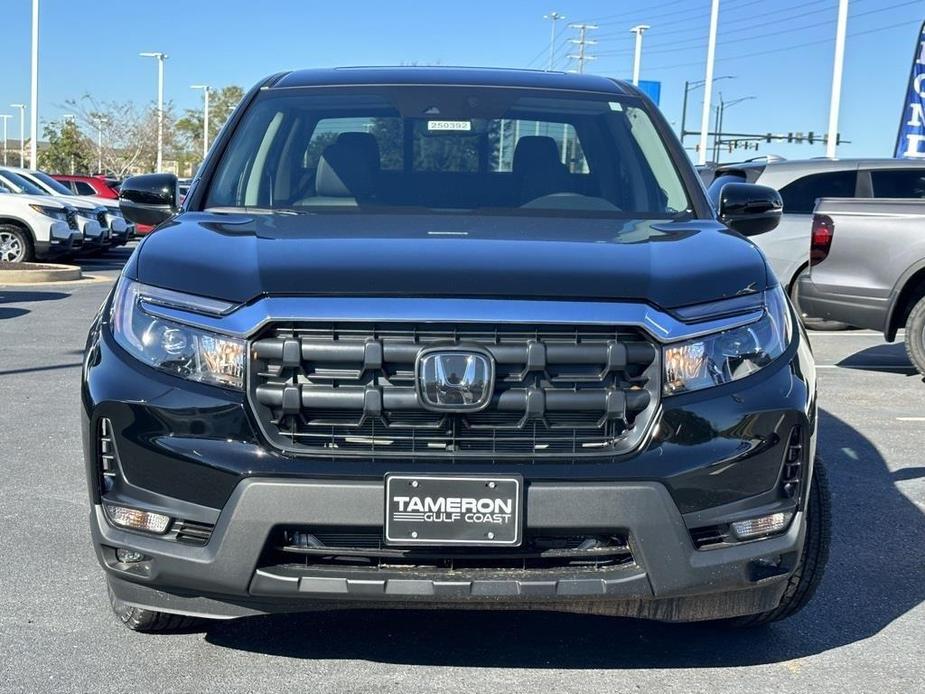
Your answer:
[799,198,925,374]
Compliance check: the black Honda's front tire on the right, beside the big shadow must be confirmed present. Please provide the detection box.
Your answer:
[723,458,832,628]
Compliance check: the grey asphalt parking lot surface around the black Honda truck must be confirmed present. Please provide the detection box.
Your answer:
[0,250,925,692]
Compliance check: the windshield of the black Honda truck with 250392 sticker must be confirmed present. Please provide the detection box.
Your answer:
[205,87,690,218]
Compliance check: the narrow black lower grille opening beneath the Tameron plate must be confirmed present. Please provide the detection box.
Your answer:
[262,527,635,571]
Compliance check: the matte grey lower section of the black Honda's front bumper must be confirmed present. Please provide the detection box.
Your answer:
[101,478,804,621]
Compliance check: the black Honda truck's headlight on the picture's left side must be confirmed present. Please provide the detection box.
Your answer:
[110,277,246,389]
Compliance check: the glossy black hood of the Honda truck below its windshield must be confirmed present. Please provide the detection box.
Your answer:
[127,212,773,308]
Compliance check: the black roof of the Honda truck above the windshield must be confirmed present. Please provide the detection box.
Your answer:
[267,66,635,95]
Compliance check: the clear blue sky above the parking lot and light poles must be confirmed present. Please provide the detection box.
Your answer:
[0,0,925,158]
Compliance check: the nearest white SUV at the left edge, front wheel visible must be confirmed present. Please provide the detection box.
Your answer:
[0,181,83,263]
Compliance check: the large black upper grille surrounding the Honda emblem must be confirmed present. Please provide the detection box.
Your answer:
[248,324,659,459]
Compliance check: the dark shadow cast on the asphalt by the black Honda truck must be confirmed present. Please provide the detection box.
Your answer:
[205,411,925,669]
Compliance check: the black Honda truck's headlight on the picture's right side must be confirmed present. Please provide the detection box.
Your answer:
[662,286,793,395]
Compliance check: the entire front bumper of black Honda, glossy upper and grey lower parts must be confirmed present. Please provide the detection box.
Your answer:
[83,308,816,620]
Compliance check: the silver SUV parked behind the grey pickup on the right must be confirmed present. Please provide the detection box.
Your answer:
[713,159,925,330]
